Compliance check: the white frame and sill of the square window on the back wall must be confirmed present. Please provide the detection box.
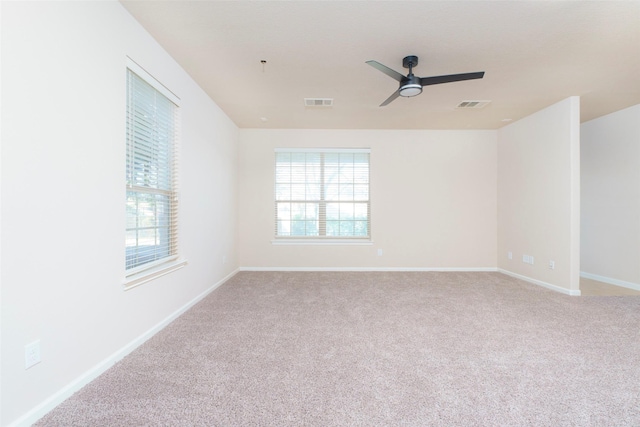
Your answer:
[271,148,373,245]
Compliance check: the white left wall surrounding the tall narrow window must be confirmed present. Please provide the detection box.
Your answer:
[0,1,238,425]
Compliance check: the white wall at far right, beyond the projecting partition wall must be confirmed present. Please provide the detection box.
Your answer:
[580,105,640,289]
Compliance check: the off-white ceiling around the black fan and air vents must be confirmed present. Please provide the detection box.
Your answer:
[121,0,640,129]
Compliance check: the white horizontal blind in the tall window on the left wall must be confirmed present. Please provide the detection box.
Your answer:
[125,69,179,274]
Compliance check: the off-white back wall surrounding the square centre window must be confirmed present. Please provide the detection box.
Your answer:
[238,129,496,269]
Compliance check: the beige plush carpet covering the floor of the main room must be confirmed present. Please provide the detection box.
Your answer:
[37,272,640,427]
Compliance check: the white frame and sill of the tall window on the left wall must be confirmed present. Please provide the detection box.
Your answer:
[124,57,187,289]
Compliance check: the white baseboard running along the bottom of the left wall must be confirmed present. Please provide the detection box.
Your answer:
[13,269,239,427]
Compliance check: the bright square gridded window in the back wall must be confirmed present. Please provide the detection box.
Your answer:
[275,149,371,239]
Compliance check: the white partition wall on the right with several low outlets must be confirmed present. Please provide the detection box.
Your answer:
[498,97,580,294]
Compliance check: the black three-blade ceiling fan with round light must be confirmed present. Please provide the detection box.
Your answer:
[367,55,484,107]
